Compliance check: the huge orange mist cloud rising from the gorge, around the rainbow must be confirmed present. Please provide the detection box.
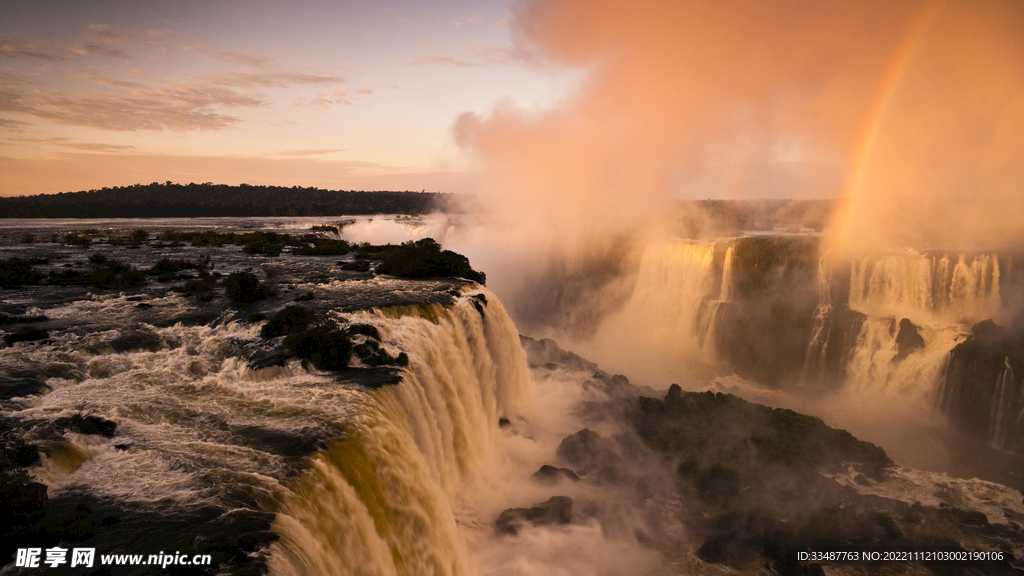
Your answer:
[454,0,1024,337]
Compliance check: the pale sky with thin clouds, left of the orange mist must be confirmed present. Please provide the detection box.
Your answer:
[0,0,579,196]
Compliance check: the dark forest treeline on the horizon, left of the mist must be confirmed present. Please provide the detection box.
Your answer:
[0,181,454,218]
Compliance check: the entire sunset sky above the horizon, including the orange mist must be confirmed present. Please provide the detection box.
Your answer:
[0,0,1024,217]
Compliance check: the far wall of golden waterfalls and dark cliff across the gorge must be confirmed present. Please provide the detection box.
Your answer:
[590,237,1018,446]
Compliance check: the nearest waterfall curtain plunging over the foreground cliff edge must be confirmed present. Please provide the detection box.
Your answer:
[270,292,532,576]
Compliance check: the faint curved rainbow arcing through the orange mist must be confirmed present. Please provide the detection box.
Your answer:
[829,0,943,256]
